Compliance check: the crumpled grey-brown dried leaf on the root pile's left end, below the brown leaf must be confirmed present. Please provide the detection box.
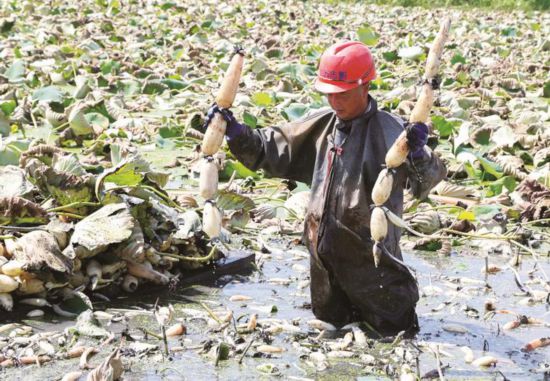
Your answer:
[12,230,73,273]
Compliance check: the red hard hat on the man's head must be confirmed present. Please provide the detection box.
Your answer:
[315,41,376,94]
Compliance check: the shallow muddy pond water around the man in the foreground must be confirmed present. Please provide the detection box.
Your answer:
[0,236,550,380]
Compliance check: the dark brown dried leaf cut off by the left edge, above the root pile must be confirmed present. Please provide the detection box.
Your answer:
[0,197,49,225]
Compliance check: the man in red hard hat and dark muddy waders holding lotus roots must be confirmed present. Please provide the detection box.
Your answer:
[205,42,446,336]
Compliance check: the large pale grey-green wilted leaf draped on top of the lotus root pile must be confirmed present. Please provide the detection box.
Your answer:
[71,203,134,258]
